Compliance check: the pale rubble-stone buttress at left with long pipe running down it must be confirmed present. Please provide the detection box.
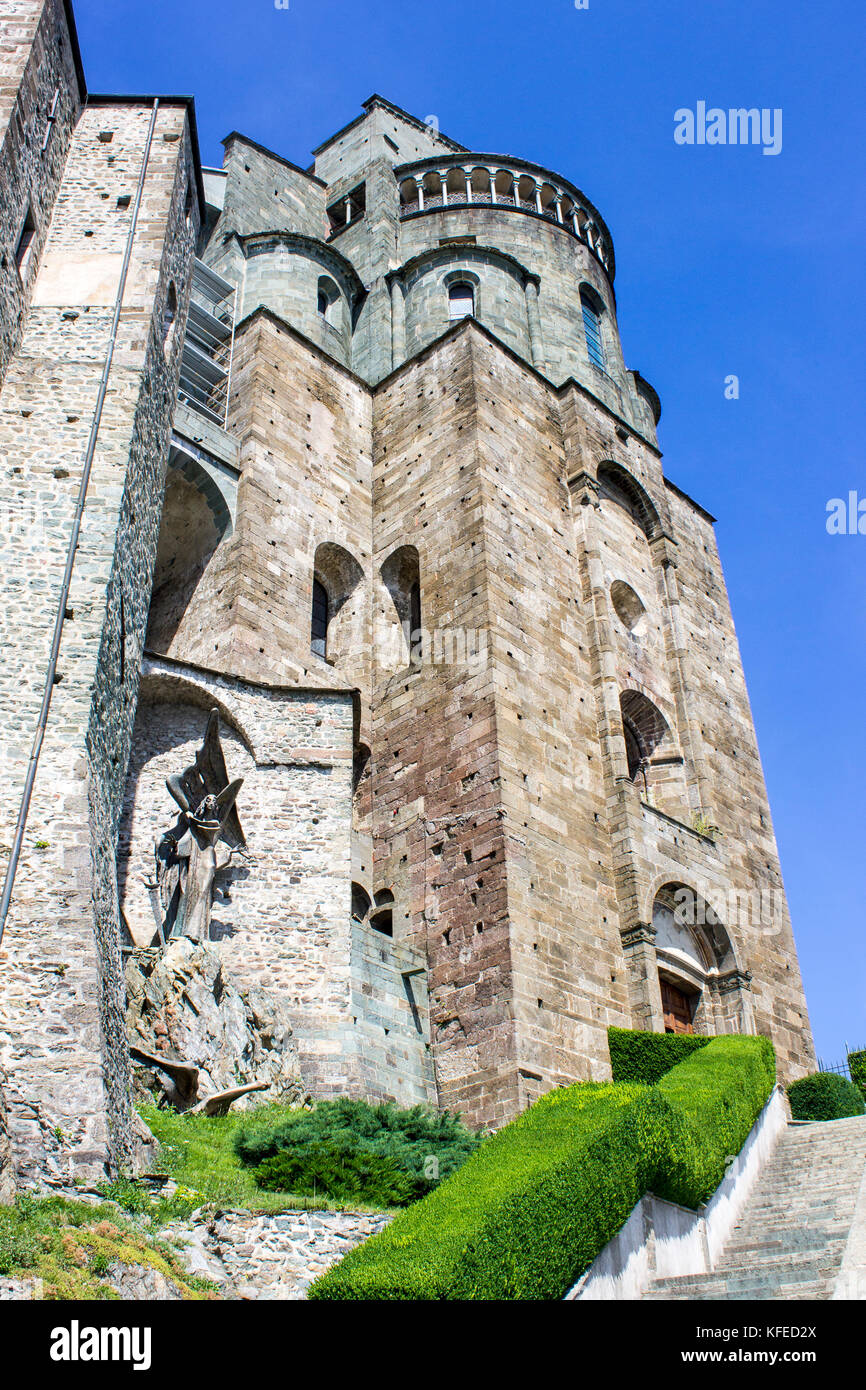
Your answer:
[0,104,197,1183]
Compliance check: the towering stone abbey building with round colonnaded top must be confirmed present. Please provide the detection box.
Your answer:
[0,0,815,1182]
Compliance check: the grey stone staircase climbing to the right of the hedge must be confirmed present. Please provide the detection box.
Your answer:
[644,1118,866,1300]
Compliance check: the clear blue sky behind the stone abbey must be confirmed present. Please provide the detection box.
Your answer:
[75,0,866,1061]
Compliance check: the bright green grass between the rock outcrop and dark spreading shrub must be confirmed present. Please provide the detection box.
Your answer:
[142,1104,397,1220]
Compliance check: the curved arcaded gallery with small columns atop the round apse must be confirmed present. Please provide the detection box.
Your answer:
[395,154,614,279]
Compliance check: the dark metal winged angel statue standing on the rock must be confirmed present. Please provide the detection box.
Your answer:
[156,709,246,941]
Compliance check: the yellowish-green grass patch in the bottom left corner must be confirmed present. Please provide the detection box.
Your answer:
[0,1195,211,1302]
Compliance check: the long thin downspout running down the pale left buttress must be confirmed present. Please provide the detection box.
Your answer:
[0,97,160,942]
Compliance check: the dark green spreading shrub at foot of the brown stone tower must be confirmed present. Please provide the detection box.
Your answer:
[235,1099,481,1207]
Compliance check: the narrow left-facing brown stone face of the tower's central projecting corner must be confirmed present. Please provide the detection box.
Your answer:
[373,319,518,1123]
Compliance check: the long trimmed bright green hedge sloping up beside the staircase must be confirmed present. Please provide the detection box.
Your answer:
[310,1037,776,1300]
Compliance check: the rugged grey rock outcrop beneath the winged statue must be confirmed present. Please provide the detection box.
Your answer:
[126,937,307,1109]
